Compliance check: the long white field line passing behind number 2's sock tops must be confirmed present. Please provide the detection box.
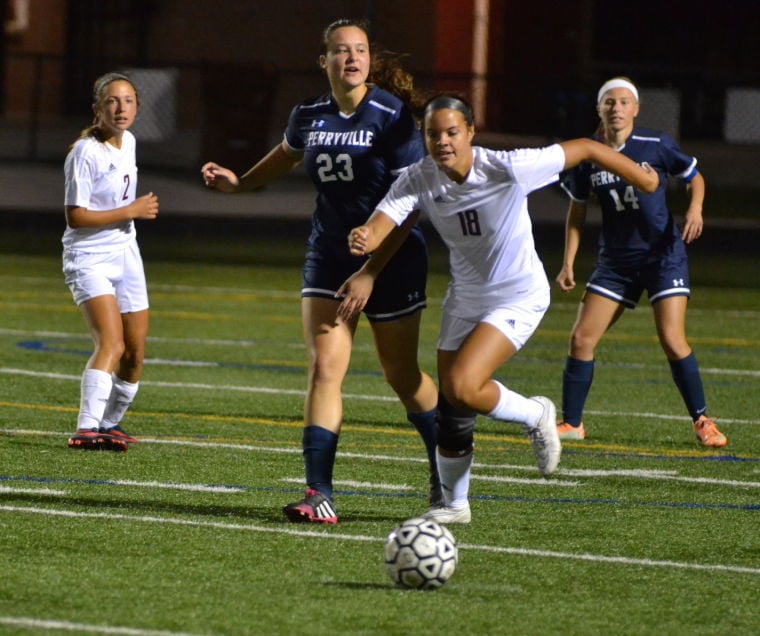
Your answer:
[0,367,760,425]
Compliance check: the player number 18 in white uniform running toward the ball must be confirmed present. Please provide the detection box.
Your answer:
[341,94,658,523]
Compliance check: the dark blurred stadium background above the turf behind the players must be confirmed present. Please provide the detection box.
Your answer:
[0,0,760,227]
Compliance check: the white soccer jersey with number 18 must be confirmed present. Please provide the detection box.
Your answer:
[377,144,565,318]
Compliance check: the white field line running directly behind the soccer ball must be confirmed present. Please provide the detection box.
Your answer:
[0,505,760,575]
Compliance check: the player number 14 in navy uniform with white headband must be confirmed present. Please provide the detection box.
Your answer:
[556,77,726,447]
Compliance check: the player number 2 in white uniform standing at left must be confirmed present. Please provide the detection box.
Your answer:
[62,73,158,451]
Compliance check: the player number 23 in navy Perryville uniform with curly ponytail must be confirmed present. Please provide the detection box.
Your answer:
[201,20,441,523]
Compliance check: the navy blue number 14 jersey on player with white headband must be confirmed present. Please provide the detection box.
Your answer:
[561,126,697,266]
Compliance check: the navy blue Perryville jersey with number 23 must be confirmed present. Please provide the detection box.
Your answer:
[285,86,425,246]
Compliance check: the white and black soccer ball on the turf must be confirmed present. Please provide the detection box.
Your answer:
[383,517,459,590]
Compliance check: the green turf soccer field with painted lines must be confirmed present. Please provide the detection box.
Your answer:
[0,225,760,636]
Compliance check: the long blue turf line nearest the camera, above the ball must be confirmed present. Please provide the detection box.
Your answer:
[0,475,760,512]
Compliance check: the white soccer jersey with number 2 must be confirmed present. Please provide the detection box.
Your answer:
[63,131,137,252]
